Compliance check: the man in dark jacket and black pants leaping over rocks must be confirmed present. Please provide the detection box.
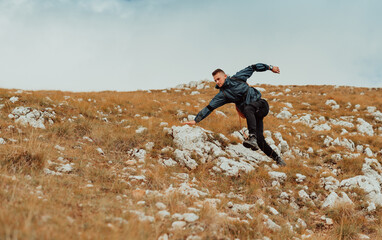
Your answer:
[184,63,286,166]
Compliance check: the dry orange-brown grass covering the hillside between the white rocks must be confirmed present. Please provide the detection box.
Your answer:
[0,83,382,239]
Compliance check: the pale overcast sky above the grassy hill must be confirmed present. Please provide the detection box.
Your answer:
[0,0,382,91]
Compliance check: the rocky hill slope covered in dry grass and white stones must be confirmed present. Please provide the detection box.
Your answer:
[0,82,382,239]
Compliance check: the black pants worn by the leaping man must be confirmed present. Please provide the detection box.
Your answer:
[243,99,278,159]
